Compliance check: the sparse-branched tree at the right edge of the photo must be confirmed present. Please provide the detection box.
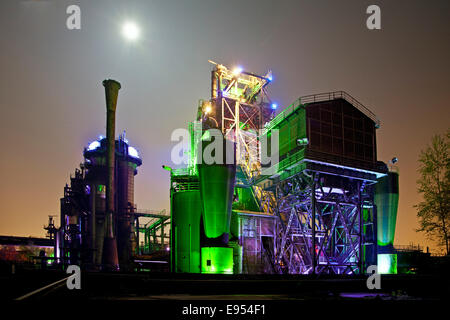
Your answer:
[414,129,450,255]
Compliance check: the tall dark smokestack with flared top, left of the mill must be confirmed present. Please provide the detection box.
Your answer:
[103,79,120,270]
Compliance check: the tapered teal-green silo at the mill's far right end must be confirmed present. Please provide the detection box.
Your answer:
[375,172,398,253]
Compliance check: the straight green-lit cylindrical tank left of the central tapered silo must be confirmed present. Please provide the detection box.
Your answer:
[172,190,201,273]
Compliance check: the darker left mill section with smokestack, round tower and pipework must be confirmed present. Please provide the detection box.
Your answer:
[52,80,170,271]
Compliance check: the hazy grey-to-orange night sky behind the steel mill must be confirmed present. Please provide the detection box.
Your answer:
[0,0,450,254]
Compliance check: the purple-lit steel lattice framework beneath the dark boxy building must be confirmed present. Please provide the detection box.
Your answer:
[274,170,376,274]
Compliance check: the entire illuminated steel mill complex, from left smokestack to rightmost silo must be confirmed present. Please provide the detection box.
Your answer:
[46,61,398,274]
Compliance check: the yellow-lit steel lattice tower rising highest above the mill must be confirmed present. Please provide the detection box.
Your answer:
[201,61,275,213]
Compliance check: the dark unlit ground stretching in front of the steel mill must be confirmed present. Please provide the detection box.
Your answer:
[0,270,450,319]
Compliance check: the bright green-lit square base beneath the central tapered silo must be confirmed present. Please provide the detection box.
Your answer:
[201,247,233,274]
